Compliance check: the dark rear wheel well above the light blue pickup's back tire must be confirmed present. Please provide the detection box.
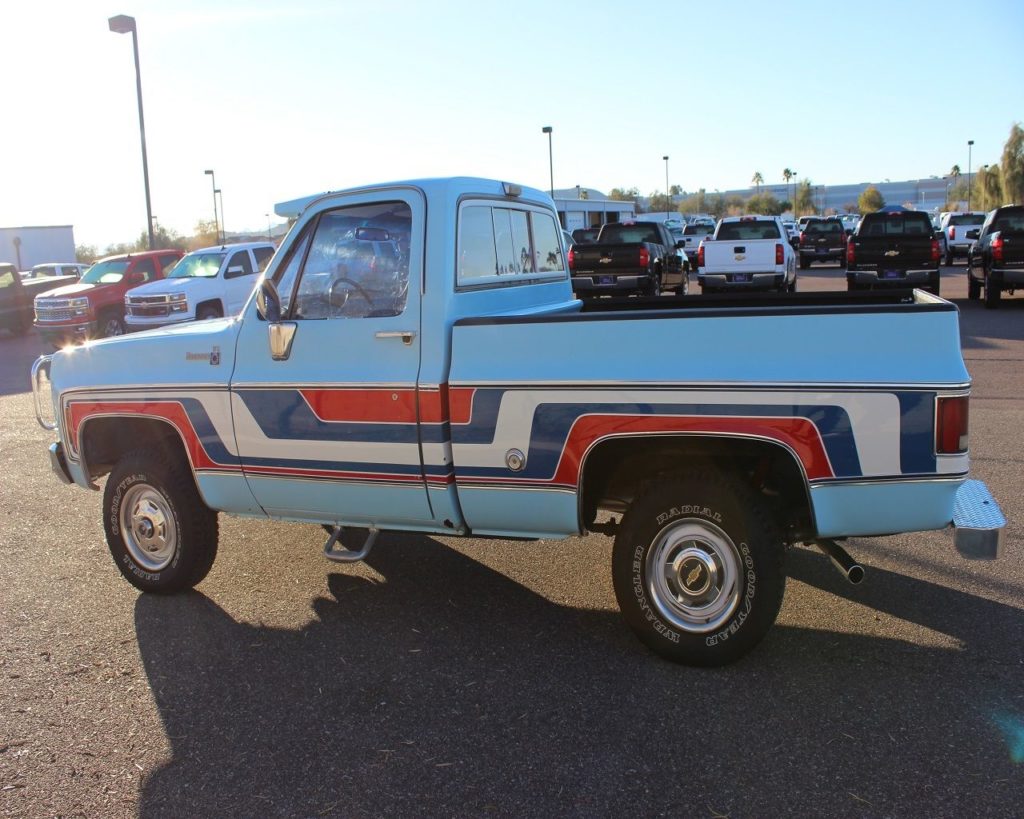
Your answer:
[580,435,816,541]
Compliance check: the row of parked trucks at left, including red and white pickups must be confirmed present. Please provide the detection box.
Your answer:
[0,242,274,347]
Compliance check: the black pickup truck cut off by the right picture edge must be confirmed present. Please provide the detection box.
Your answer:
[967,205,1024,308]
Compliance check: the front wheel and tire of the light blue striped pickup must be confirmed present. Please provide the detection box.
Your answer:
[103,449,217,594]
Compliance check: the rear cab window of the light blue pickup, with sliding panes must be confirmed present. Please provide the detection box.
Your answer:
[456,200,566,288]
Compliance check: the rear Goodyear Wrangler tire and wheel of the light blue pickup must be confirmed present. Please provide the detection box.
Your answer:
[611,472,785,665]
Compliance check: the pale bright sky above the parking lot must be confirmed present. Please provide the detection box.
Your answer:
[0,0,1024,250]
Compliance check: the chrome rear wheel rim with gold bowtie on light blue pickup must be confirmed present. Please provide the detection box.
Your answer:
[645,520,742,634]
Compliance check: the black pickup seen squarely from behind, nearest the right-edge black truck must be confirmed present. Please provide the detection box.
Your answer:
[846,210,941,296]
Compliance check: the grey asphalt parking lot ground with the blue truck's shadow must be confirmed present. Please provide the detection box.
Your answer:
[0,265,1024,819]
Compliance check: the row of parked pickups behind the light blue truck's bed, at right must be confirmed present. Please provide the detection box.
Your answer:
[567,206,1024,307]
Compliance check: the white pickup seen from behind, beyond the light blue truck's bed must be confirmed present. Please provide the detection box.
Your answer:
[697,216,797,293]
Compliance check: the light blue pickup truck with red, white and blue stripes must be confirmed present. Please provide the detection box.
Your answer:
[33,178,1006,665]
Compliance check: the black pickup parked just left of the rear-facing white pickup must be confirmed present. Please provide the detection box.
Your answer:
[569,222,689,296]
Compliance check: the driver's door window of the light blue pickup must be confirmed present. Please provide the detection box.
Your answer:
[282,202,413,319]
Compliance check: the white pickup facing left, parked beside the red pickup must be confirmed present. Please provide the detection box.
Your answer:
[125,242,274,331]
